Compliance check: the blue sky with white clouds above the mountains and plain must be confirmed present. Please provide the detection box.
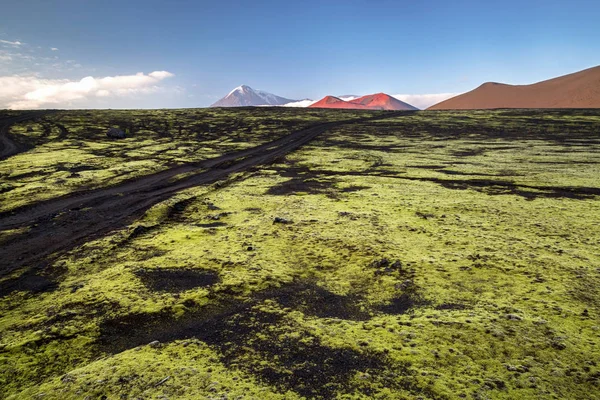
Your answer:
[0,0,600,109]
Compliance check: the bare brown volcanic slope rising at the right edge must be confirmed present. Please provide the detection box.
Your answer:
[428,66,600,110]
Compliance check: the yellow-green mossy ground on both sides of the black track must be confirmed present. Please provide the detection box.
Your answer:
[0,109,600,399]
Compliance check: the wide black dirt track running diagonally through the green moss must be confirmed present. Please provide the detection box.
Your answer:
[0,112,406,277]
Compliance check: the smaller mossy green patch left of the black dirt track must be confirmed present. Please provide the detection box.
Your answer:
[0,108,364,212]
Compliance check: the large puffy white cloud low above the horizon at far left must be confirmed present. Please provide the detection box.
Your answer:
[0,71,174,109]
